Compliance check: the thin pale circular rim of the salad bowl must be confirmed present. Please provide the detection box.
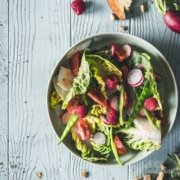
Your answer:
[46,32,179,167]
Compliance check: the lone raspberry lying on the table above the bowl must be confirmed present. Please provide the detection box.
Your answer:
[71,0,85,15]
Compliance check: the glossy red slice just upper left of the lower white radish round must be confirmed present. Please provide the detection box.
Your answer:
[77,119,91,141]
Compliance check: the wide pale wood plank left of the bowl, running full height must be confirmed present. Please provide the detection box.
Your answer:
[9,0,71,180]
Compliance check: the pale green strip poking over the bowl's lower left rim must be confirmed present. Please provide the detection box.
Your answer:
[58,114,79,144]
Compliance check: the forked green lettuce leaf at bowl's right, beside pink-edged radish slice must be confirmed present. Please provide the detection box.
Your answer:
[126,51,162,127]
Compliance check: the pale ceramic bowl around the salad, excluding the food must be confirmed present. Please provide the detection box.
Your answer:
[47,33,178,165]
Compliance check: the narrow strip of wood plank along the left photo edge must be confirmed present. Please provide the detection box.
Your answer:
[0,0,8,180]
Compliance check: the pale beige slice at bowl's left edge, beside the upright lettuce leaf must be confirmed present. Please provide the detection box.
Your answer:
[57,66,74,91]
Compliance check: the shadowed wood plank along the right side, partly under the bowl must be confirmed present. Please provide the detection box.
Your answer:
[129,1,180,179]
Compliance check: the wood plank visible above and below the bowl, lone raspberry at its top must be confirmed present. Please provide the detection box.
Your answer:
[69,0,129,180]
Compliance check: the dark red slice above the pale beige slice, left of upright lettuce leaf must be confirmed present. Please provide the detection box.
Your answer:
[71,52,80,76]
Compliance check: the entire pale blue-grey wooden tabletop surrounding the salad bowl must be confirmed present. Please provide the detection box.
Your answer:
[0,0,180,180]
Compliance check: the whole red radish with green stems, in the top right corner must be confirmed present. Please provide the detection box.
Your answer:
[155,0,180,34]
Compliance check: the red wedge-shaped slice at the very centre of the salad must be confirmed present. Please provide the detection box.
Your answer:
[87,89,107,107]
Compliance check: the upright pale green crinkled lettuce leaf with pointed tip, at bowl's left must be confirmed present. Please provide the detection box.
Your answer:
[62,51,90,109]
